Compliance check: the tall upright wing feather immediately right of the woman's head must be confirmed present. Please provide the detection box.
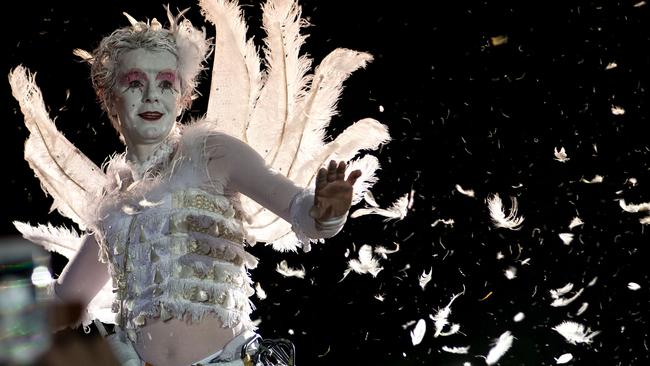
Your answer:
[199,0,262,142]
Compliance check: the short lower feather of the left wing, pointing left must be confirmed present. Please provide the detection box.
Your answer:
[13,221,82,259]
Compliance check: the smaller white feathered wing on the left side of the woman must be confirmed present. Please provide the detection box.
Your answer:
[9,66,115,325]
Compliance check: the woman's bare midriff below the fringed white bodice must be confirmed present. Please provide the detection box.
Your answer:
[135,314,244,366]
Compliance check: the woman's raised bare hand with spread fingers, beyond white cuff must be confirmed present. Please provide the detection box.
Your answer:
[309,160,361,221]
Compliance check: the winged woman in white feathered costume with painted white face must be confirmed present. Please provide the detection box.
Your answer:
[10,0,389,366]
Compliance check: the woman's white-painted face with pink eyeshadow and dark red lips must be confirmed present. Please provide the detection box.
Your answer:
[113,49,180,145]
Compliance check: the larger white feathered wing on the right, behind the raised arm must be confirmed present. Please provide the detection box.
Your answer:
[201,0,390,251]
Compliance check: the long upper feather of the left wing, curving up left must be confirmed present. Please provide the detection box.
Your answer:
[9,66,107,229]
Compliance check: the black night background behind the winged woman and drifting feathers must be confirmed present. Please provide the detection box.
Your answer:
[0,0,650,366]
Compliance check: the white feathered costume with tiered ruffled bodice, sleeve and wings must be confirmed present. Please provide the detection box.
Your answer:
[10,0,390,336]
